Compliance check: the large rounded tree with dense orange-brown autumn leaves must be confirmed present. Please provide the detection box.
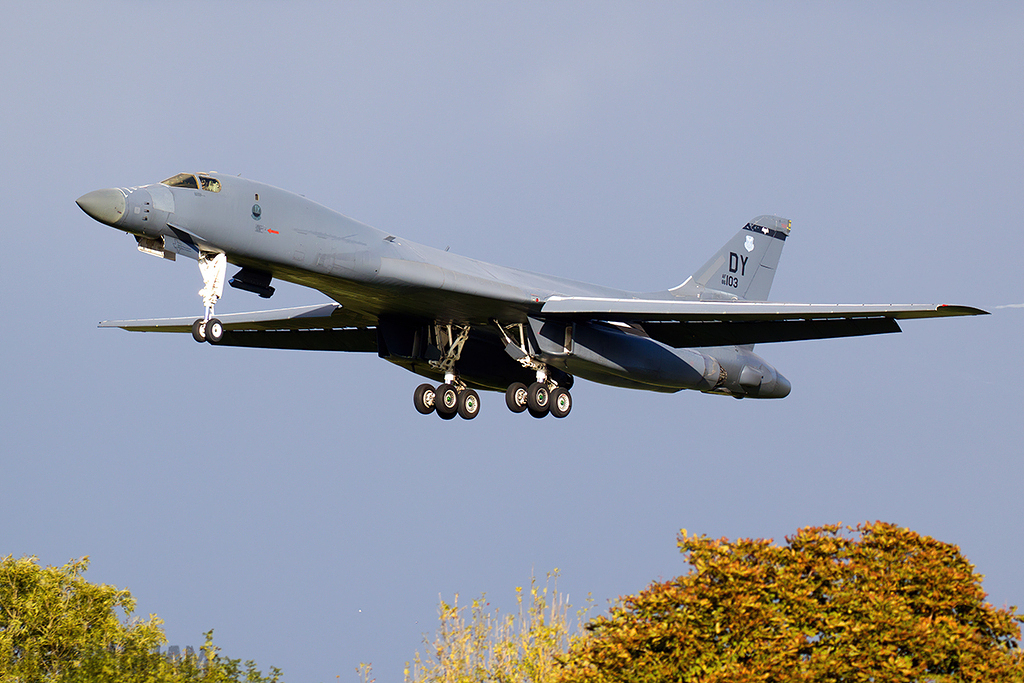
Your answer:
[561,522,1024,683]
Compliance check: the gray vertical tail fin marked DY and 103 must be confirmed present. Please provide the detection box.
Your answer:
[670,216,791,301]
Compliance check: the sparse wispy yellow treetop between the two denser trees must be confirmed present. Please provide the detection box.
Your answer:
[399,570,590,683]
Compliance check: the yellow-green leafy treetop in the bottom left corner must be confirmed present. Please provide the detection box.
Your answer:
[0,555,280,683]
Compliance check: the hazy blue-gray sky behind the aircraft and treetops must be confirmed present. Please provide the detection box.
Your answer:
[0,2,1024,682]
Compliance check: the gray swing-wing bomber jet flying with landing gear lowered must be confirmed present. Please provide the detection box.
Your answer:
[78,173,986,419]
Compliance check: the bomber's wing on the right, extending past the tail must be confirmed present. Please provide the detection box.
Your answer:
[542,297,988,348]
